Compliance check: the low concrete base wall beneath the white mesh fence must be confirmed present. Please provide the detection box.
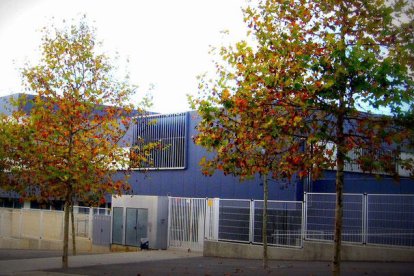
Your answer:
[203,241,414,262]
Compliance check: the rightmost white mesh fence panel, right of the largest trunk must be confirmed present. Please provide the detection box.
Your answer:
[367,195,414,246]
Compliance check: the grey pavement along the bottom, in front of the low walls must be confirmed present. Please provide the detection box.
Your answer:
[0,249,414,276]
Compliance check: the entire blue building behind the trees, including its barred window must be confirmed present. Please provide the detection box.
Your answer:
[0,94,414,206]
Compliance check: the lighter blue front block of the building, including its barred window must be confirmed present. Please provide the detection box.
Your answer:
[118,111,303,200]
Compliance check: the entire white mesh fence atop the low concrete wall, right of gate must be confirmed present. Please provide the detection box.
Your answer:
[199,193,414,250]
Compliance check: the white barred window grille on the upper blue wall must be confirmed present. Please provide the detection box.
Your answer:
[132,113,187,169]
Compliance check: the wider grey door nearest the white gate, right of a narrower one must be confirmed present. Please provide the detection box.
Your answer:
[125,208,148,246]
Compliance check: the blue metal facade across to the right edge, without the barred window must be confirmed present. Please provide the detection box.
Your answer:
[121,112,414,200]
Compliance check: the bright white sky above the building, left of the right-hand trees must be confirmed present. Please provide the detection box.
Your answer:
[0,0,246,113]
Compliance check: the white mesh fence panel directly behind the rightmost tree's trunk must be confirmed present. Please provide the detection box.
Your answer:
[305,193,364,243]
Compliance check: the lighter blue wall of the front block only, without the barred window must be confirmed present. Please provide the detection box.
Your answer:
[119,112,303,200]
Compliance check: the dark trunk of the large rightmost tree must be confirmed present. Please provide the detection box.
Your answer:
[332,110,346,275]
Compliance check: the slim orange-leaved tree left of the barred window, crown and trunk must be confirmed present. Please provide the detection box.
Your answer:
[2,19,149,268]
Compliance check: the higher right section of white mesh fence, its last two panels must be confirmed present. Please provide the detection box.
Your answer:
[304,193,414,247]
